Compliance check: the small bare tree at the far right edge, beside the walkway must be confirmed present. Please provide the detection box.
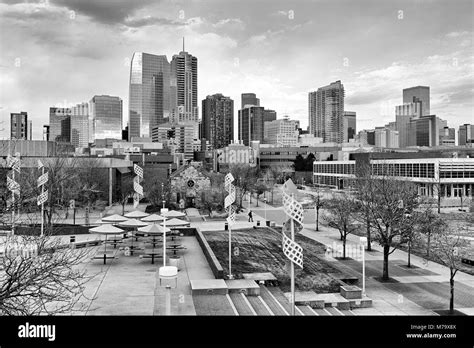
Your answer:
[431,227,469,313]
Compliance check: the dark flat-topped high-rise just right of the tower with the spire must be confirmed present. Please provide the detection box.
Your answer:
[201,94,234,149]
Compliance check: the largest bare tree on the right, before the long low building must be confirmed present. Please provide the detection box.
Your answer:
[352,163,420,280]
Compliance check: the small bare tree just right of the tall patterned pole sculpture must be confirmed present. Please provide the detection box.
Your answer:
[324,194,358,259]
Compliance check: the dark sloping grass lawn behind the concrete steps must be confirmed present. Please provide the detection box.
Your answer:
[203,228,340,293]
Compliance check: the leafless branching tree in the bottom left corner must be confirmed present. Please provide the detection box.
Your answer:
[0,235,92,315]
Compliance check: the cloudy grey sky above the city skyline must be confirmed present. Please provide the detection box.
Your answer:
[0,0,474,139]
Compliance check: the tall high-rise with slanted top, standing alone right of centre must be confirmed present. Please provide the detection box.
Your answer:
[308,81,344,143]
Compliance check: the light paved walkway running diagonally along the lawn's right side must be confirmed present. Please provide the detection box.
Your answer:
[241,199,474,315]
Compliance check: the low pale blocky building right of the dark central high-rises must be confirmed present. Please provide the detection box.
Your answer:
[264,116,299,146]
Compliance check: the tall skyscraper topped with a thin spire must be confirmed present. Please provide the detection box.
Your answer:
[170,47,199,123]
